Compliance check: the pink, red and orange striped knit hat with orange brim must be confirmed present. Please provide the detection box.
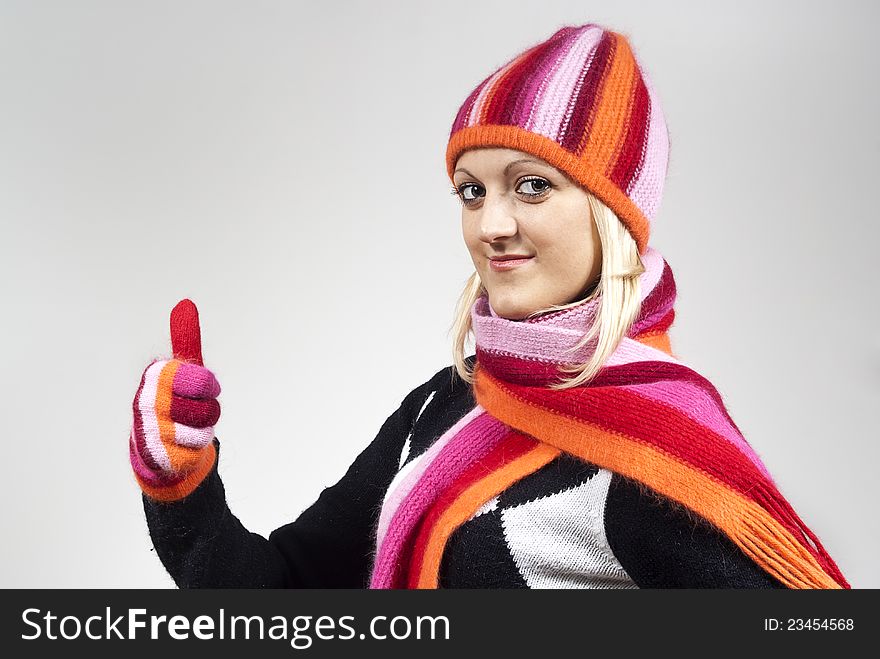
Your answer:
[446,23,669,254]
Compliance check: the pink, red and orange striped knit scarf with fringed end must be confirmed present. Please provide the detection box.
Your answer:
[370,247,850,588]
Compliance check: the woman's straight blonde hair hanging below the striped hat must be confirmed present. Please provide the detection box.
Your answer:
[450,192,645,389]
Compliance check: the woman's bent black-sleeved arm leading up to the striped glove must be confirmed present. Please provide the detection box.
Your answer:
[143,369,447,588]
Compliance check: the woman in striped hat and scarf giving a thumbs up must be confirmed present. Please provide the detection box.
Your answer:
[129,24,849,588]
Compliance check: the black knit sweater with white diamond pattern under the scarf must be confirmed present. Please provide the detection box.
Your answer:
[143,356,785,588]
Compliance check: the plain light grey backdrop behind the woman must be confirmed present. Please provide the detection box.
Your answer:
[0,0,880,587]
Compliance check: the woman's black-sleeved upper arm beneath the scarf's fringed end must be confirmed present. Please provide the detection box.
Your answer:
[605,474,786,588]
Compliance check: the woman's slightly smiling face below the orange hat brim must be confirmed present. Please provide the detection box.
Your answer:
[453,147,602,320]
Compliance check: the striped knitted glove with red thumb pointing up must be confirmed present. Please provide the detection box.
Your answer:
[128,299,220,501]
